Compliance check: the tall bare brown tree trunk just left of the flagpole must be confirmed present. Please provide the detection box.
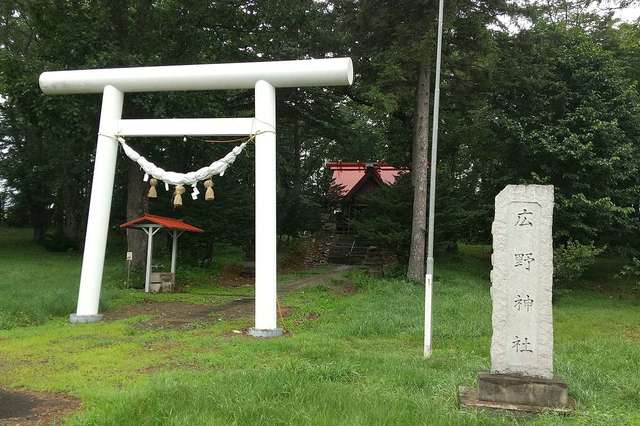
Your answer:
[407,62,431,282]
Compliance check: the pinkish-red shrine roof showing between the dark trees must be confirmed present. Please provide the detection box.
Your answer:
[327,161,408,197]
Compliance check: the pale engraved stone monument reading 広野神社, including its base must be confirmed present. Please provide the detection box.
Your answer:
[459,185,569,411]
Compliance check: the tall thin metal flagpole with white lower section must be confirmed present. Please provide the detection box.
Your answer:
[424,0,444,358]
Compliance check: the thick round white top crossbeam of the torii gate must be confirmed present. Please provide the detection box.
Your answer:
[40,58,353,95]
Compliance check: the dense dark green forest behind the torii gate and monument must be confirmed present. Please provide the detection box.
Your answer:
[0,0,640,279]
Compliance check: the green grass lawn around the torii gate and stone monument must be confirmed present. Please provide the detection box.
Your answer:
[0,228,640,425]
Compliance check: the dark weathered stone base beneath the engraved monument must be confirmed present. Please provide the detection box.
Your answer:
[458,373,574,413]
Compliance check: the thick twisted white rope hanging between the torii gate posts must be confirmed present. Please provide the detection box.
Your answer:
[118,137,247,186]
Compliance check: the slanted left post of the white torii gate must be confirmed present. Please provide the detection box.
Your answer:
[69,86,124,323]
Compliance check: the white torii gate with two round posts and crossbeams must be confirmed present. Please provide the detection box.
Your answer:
[40,58,353,337]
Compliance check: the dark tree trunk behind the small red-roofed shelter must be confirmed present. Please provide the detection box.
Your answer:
[127,161,149,267]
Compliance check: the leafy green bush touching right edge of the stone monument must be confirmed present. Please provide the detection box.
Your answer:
[553,241,606,281]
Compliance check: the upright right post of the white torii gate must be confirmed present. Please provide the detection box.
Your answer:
[249,80,282,337]
